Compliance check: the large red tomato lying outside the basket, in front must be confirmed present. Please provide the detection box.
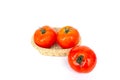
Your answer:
[68,46,97,73]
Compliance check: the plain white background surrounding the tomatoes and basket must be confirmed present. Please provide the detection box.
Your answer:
[0,0,120,80]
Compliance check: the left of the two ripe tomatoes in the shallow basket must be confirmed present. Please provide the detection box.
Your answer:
[34,26,57,48]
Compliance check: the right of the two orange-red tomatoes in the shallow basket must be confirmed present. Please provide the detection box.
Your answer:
[57,26,80,48]
